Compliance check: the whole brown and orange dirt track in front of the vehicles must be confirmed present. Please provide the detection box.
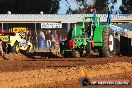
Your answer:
[0,55,132,88]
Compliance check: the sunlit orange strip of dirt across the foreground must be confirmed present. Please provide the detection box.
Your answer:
[0,62,132,88]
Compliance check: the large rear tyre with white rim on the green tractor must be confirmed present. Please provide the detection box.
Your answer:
[99,27,115,57]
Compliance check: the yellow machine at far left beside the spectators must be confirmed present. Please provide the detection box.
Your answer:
[0,27,32,53]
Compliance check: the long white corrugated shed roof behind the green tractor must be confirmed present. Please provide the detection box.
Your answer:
[0,14,132,23]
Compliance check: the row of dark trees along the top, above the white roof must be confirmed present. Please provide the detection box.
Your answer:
[0,0,132,14]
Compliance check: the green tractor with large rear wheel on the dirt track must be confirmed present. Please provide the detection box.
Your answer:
[60,8,114,57]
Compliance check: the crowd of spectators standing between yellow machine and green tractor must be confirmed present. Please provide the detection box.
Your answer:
[27,30,63,49]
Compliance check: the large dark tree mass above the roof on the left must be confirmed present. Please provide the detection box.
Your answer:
[0,0,59,14]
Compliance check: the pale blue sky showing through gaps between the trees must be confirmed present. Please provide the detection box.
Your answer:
[58,0,122,14]
